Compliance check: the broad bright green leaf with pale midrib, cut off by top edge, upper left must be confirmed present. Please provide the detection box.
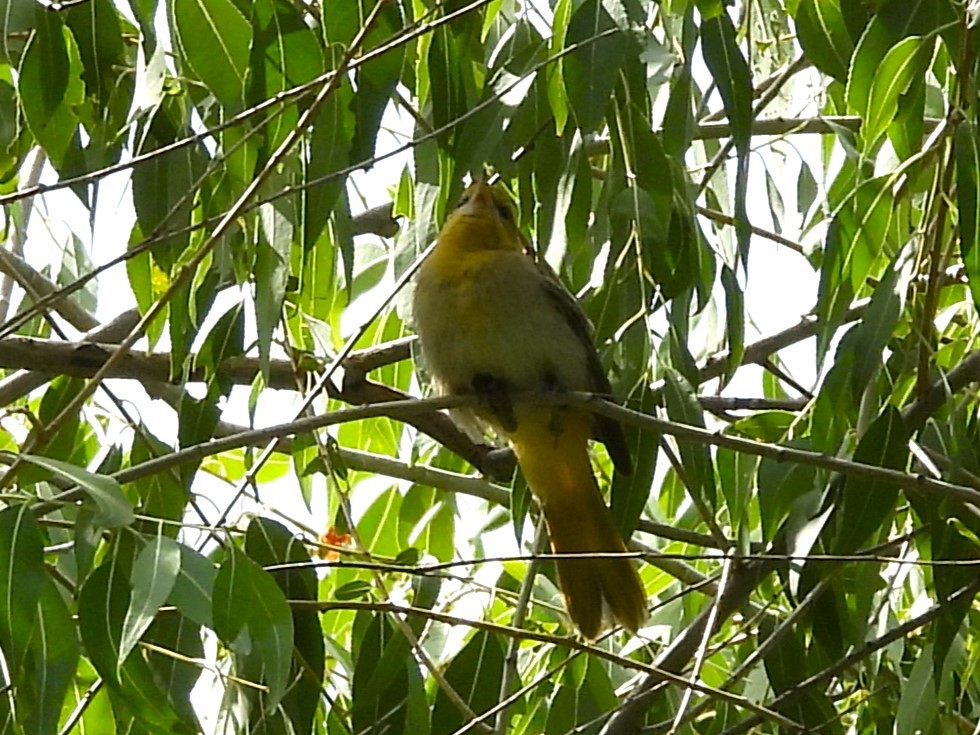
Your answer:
[170,0,252,112]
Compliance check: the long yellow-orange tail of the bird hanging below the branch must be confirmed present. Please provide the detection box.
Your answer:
[510,407,647,640]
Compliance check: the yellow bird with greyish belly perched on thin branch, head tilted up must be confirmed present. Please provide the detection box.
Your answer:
[414,181,647,640]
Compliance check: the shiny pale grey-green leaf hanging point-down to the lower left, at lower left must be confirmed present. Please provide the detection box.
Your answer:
[118,532,180,667]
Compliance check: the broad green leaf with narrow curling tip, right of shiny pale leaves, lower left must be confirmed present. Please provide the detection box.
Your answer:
[213,546,293,712]
